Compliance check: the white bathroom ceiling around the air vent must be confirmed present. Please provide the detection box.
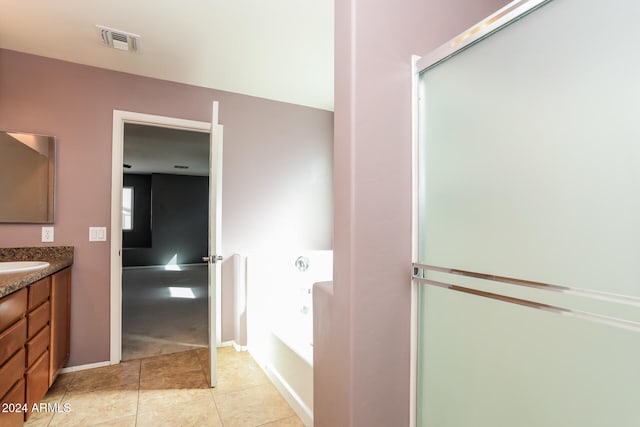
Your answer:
[0,0,333,111]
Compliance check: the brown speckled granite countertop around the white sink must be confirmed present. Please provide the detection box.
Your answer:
[0,246,73,297]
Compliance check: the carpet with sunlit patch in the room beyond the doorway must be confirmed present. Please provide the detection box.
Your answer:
[122,264,208,360]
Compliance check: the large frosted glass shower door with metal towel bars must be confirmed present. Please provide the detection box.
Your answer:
[414,0,640,427]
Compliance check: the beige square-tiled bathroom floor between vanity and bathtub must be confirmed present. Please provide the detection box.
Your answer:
[26,347,303,427]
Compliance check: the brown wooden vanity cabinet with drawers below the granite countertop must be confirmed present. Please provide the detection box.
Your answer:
[0,267,71,427]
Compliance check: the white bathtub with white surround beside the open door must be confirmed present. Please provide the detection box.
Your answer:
[247,251,333,426]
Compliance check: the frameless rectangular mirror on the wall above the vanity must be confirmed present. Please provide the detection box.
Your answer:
[0,131,56,224]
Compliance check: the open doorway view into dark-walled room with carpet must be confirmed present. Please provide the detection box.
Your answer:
[121,123,210,360]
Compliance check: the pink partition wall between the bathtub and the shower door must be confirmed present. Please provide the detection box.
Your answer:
[314,0,507,427]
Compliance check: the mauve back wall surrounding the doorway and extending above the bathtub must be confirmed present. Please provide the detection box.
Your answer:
[0,49,333,366]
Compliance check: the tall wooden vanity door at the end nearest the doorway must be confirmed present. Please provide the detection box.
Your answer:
[49,267,71,386]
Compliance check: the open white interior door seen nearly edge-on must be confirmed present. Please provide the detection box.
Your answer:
[206,102,222,387]
